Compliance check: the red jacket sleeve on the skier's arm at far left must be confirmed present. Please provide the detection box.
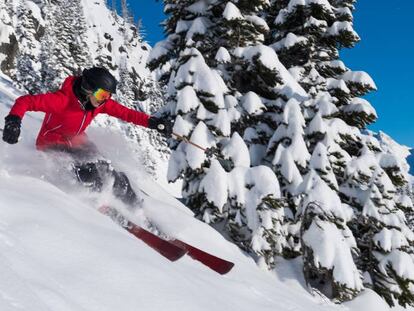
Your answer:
[10,90,68,118]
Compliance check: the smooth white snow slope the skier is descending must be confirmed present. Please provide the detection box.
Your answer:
[0,76,408,311]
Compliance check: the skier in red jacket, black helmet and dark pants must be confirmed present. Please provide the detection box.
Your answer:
[3,67,172,206]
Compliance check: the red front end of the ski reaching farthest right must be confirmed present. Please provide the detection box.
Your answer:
[170,239,234,274]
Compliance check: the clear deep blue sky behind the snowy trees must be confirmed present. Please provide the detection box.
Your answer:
[129,0,414,147]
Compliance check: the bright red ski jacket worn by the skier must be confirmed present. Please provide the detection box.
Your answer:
[10,77,150,150]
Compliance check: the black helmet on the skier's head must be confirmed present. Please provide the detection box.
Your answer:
[81,67,117,93]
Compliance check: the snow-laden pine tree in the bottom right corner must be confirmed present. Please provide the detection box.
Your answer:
[346,149,414,306]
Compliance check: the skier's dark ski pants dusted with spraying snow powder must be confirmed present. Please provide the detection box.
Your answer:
[46,143,138,207]
